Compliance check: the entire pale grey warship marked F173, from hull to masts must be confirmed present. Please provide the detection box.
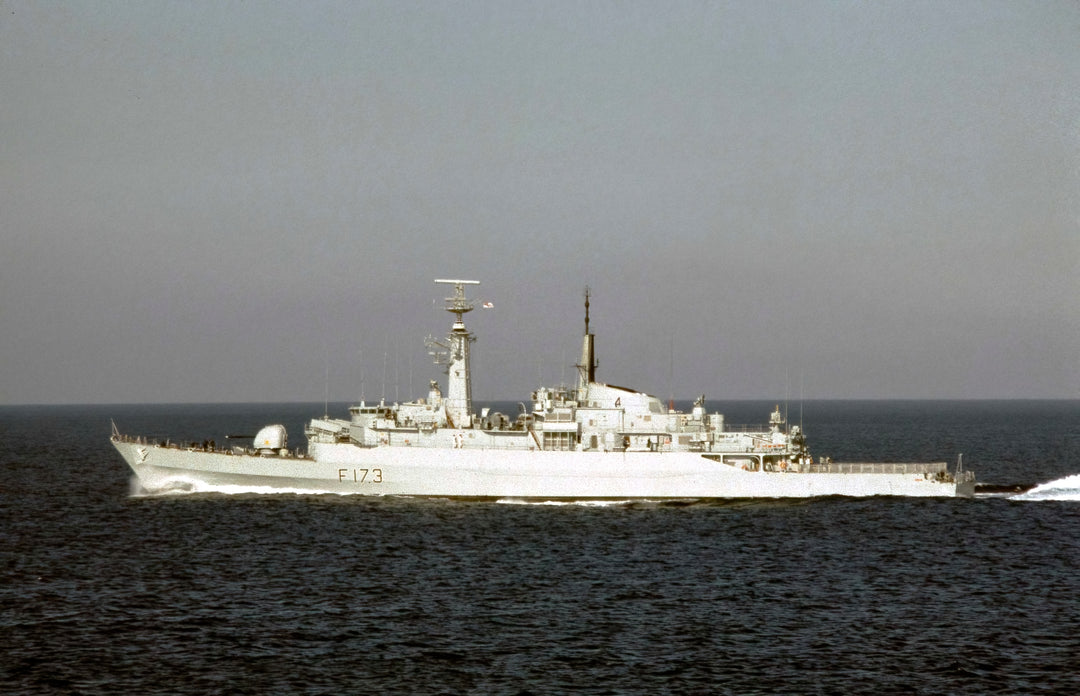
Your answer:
[111,279,975,500]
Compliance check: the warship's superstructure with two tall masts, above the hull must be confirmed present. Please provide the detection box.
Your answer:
[306,280,811,470]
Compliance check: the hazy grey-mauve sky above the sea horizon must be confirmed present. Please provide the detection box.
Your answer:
[0,0,1080,403]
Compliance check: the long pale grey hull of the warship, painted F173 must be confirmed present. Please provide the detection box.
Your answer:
[113,437,974,500]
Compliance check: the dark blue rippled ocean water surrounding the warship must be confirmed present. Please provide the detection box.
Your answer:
[0,401,1080,695]
